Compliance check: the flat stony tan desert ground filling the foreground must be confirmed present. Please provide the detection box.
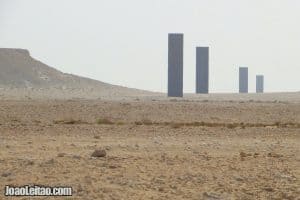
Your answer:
[0,100,300,200]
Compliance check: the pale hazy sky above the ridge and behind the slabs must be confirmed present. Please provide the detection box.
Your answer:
[0,0,300,92]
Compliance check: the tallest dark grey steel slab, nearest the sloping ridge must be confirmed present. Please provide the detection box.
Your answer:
[168,33,183,97]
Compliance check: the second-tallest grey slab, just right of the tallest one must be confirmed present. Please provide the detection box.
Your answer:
[196,47,209,94]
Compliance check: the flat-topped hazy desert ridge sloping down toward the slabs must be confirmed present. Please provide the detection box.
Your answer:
[0,48,152,98]
